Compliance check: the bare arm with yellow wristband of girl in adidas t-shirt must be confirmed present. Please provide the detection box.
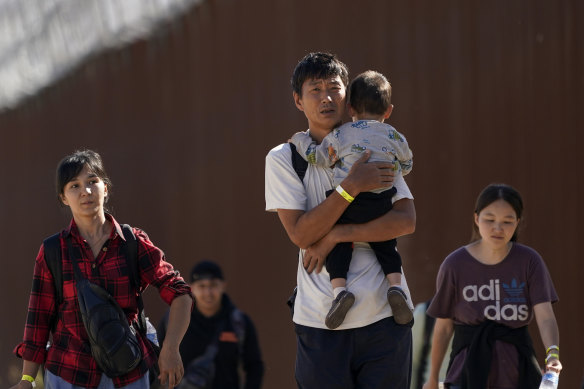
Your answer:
[533,301,562,373]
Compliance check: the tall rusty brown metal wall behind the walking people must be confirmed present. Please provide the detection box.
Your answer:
[0,0,584,388]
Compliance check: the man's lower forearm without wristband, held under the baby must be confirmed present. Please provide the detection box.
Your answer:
[332,199,416,242]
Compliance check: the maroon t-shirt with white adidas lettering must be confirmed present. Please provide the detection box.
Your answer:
[428,243,558,389]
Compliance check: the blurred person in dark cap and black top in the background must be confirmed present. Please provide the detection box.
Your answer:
[158,261,264,389]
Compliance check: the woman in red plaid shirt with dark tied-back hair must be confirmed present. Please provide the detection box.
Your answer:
[11,150,193,389]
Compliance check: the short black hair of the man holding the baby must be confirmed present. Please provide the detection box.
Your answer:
[290,52,349,96]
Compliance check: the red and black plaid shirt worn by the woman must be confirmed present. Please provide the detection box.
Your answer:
[14,215,191,388]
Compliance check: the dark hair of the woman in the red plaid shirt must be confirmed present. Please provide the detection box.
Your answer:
[55,150,112,205]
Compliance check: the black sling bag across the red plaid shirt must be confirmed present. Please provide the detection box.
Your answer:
[67,238,142,377]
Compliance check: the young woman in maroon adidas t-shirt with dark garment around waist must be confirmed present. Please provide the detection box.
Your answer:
[423,184,562,389]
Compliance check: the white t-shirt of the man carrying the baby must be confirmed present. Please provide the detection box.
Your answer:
[265,143,413,330]
